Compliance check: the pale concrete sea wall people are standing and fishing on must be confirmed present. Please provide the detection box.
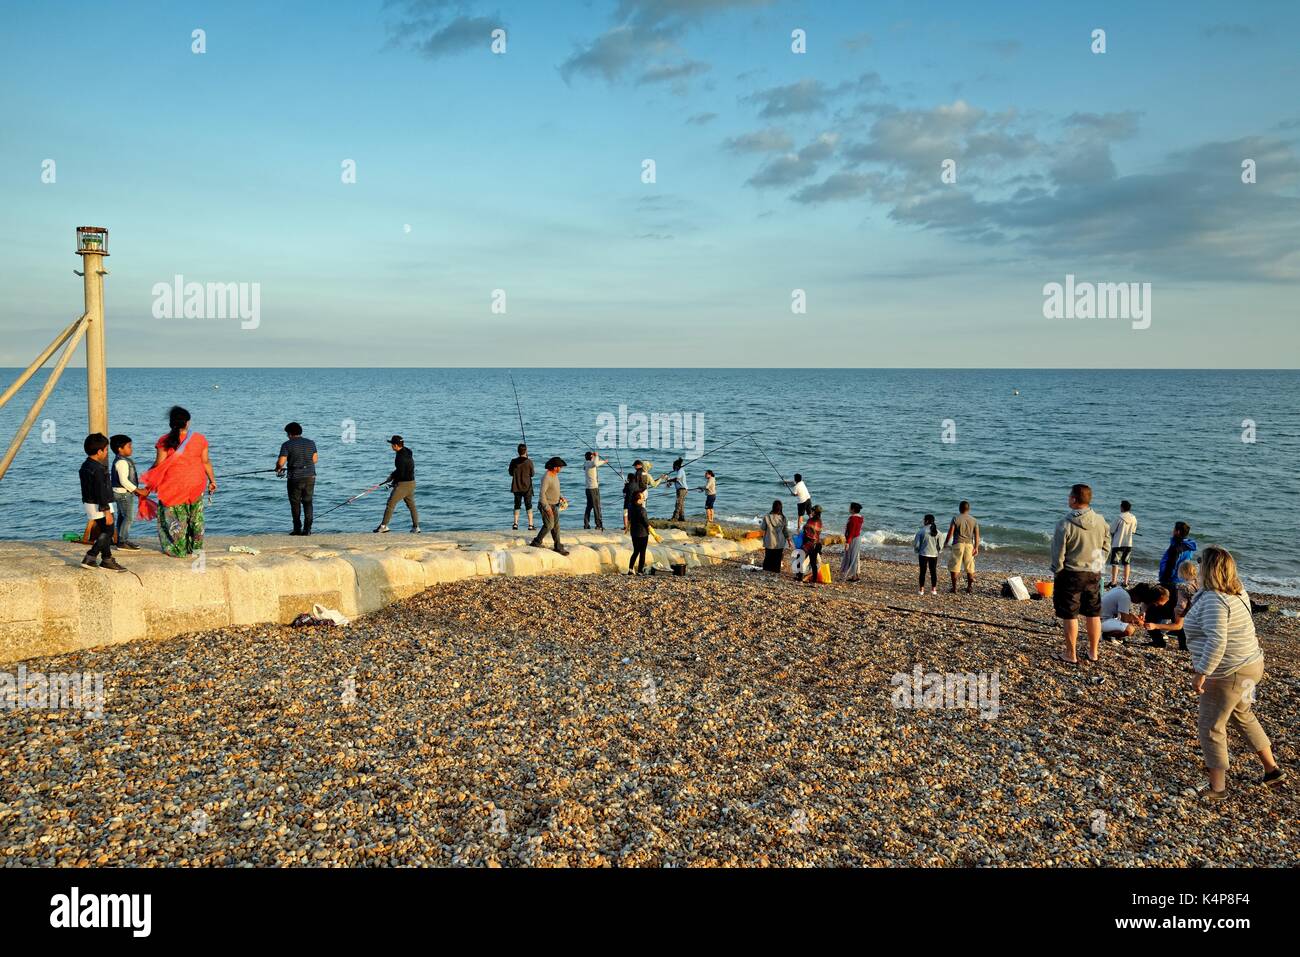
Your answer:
[0,529,761,662]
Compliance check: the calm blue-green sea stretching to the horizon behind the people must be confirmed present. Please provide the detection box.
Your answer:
[0,369,1300,593]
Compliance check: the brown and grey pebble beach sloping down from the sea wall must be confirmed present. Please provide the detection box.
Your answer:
[0,549,1300,867]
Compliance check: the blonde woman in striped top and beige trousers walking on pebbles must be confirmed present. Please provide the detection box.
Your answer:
[1183,545,1283,801]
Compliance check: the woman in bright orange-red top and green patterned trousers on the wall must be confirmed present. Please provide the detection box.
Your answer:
[140,406,217,558]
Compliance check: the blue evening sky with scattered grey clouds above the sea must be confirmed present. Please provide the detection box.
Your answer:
[0,0,1300,368]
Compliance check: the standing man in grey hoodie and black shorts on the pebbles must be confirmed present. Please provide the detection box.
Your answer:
[1052,485,1110,664]
